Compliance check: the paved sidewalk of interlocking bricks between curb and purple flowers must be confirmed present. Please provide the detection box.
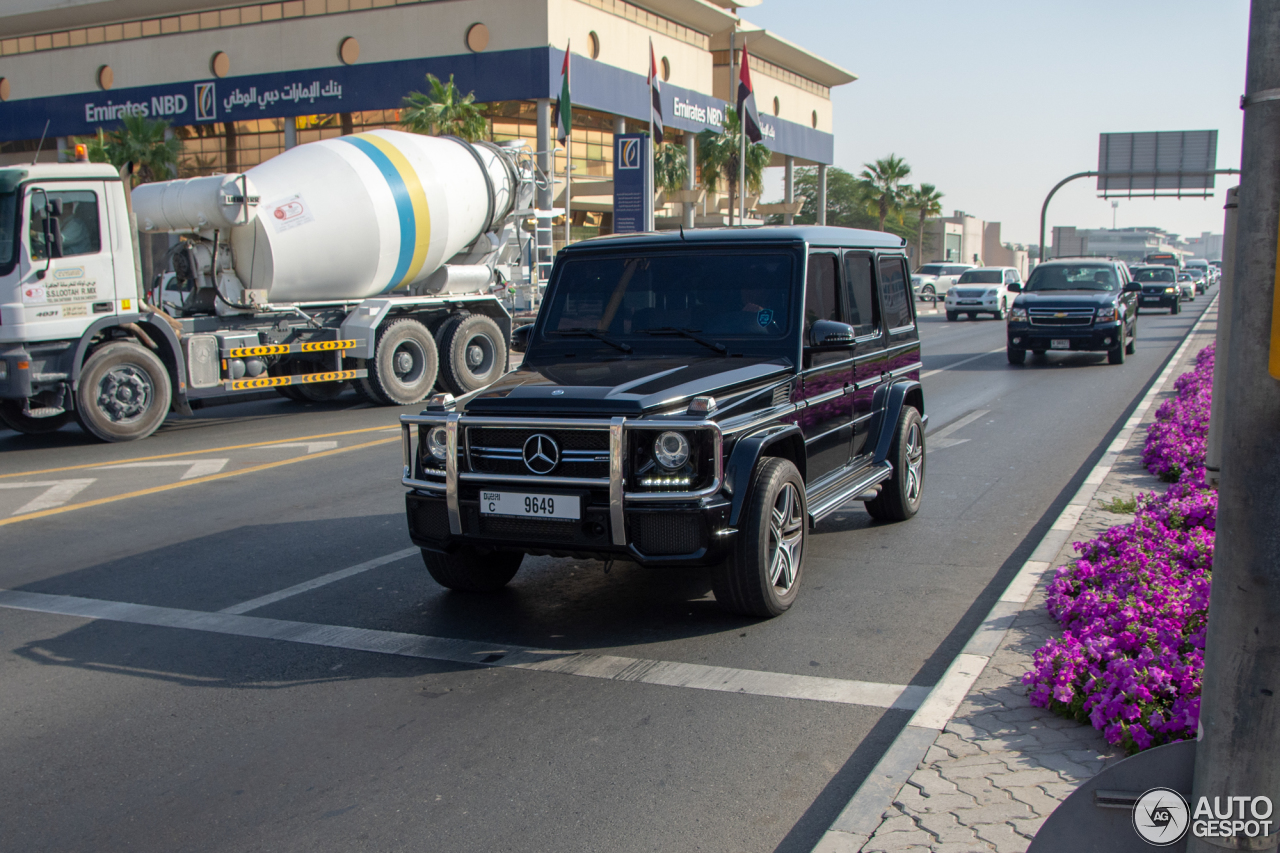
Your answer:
[861,306,1217,853]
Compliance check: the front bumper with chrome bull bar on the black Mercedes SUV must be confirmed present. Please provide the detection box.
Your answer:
[401,414,733,566]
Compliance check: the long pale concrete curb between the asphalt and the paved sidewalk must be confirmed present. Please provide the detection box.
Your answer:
[813,295,1217,853]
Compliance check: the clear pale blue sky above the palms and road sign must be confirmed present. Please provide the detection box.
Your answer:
[741,0,1249,243]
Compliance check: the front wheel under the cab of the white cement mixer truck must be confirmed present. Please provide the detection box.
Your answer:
[76,341,173,442]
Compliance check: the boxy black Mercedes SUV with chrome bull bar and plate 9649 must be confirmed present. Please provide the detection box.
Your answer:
[401,227,925,616]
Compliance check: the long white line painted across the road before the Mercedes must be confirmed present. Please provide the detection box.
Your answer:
[0,589,929,711]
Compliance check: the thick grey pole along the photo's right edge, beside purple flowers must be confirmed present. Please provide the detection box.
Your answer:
[1187,0,1280,853]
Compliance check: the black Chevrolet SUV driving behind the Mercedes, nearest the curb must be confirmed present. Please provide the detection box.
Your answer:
[1006,257,1142,364]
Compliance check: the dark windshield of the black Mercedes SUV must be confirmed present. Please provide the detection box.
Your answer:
[541,251,794,351]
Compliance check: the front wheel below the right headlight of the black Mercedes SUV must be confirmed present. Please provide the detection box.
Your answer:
[712,457,809,617]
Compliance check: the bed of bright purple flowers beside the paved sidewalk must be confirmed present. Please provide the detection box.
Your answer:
[1023,346,1217,753]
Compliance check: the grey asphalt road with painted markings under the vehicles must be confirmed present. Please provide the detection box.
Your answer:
[0,297,1210,852]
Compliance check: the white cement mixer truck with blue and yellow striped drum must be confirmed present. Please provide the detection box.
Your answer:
[0,131,538,442]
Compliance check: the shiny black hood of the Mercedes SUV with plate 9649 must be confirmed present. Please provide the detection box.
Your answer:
[466,356,792,418]
